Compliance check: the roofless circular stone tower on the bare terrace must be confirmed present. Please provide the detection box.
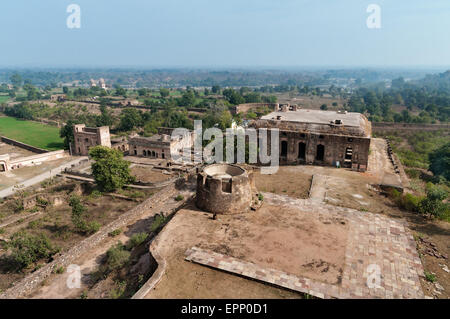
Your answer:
[197,164,254,214]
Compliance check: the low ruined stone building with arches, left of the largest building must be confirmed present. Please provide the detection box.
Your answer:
[128,128,194,160]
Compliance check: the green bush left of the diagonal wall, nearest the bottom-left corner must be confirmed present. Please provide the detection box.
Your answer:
[8,231,59,269]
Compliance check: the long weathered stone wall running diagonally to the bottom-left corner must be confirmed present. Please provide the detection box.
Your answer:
[0,179,184,299]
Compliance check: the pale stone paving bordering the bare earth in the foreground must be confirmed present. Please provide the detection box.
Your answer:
[186,193,424,299]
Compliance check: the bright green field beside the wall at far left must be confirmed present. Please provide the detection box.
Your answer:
[0,117,64,151]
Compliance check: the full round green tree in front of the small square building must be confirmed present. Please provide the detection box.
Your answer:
[89,146,135,192]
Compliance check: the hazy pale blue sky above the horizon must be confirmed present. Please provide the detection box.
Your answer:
[0,0,450,67]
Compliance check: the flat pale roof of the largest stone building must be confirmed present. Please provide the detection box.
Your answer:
[261,109,365,127]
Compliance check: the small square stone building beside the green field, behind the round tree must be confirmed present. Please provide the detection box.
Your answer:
[72,124,111,156]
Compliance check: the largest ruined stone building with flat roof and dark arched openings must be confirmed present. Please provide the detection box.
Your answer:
[250,104,372,172]
